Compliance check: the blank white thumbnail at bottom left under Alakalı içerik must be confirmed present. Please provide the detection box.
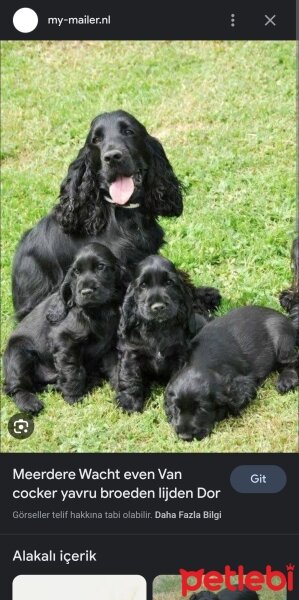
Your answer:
[12,575,146,600]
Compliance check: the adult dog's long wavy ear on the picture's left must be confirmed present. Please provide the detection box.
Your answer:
[54,144,106,235]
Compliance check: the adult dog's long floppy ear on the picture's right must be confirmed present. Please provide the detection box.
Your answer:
[145,135,183,217]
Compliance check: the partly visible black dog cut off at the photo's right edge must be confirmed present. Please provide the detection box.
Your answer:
[279,237,299,345]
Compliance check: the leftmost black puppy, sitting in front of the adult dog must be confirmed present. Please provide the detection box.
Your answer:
[4,242,125,413]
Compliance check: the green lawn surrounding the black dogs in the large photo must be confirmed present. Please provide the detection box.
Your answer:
[2,41,297,452]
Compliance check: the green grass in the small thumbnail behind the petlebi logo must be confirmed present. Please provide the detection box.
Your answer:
[153,575,286,600]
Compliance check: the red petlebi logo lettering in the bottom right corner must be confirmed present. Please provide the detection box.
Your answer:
[179,563,295,596]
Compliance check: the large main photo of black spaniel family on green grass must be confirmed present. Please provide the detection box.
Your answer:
[1,41,299,453]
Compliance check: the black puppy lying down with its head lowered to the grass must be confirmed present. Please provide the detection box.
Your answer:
[165,306,298,441]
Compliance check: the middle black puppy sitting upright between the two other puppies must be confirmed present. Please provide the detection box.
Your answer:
[117,255,207,412]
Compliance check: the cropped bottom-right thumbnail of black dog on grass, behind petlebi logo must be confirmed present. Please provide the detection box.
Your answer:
[153,575,287,600]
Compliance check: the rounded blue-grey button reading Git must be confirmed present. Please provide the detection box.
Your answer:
[230,465,287,494]
